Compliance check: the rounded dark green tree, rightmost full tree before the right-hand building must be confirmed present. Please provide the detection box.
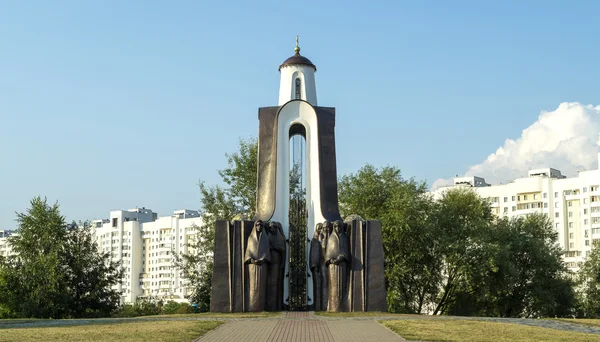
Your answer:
[448,214,574,317]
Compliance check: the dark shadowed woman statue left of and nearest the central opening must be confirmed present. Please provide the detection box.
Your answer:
[266,222,285,311]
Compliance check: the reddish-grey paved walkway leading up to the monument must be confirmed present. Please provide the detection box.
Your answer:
[196,312,405,342]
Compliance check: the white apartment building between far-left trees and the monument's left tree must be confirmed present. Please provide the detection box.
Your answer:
[92,208,201,303]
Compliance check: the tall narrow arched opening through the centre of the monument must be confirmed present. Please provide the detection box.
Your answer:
[288,123,308,311]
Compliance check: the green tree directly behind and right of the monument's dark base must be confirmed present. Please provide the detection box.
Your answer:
[338,165,441,313]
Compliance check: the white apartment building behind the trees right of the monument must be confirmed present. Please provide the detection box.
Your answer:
[433,155,600,271]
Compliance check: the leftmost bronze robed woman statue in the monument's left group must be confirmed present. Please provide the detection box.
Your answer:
[244,220,271,311]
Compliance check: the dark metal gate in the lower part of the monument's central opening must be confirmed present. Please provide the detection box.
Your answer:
[289,198,307,311]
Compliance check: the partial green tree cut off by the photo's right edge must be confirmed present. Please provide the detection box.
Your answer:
[577,245,600,318]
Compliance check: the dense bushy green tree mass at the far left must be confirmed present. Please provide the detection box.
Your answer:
[0,197,120,318]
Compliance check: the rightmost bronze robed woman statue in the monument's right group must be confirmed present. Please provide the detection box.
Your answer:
[325,220,350,312]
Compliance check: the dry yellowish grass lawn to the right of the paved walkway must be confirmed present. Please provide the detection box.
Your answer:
[381,319,600,342]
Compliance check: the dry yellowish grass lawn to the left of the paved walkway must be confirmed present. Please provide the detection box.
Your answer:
[0,321,222,342]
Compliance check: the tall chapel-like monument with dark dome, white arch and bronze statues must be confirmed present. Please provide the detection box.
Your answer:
[210,37,386,312]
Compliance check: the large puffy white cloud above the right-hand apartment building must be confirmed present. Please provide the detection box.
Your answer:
[431,102,600,190]
